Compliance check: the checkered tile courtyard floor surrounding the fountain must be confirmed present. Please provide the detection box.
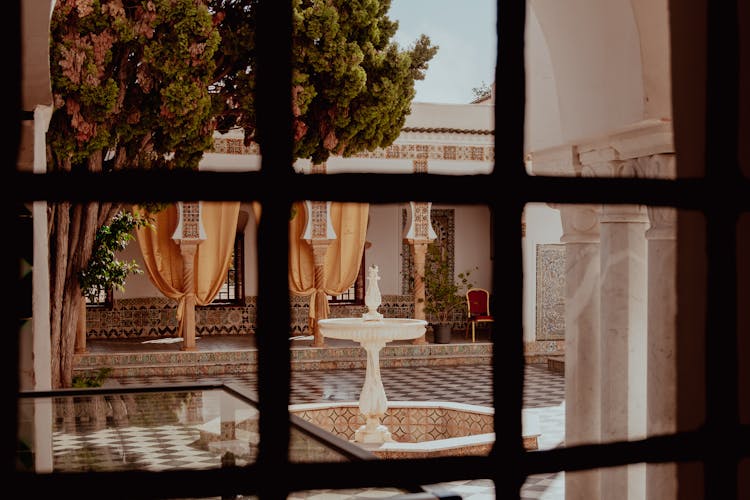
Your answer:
[83,365,565,500]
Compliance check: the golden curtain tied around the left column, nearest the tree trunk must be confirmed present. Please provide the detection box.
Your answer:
[136,201,240,338]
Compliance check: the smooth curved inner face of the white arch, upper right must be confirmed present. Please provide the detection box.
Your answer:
[530,0,646,142]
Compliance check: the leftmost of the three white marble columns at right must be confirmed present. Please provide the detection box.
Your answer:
[555,205,600,500]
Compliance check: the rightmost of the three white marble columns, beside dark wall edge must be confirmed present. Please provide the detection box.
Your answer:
[646,155,677,500]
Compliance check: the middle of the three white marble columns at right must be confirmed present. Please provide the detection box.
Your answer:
[600,197,648,500]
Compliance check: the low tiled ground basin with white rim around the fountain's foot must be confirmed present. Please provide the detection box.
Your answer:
[289,401,540,458]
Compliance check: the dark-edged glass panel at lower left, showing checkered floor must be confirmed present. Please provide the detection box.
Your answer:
[19,390,258,472]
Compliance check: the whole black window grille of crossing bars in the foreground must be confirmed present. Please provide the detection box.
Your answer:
[7,1,750,498]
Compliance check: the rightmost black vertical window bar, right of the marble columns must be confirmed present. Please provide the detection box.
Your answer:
[705,1,742,498]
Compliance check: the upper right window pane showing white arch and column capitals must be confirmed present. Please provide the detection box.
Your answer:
[524,2,680,178]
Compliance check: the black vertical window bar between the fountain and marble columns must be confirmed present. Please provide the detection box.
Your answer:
[490,1,528,499]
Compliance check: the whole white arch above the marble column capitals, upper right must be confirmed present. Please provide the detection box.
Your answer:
[528,0,671,145]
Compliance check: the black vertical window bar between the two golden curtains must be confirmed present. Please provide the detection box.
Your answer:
[256,1,293,498]
